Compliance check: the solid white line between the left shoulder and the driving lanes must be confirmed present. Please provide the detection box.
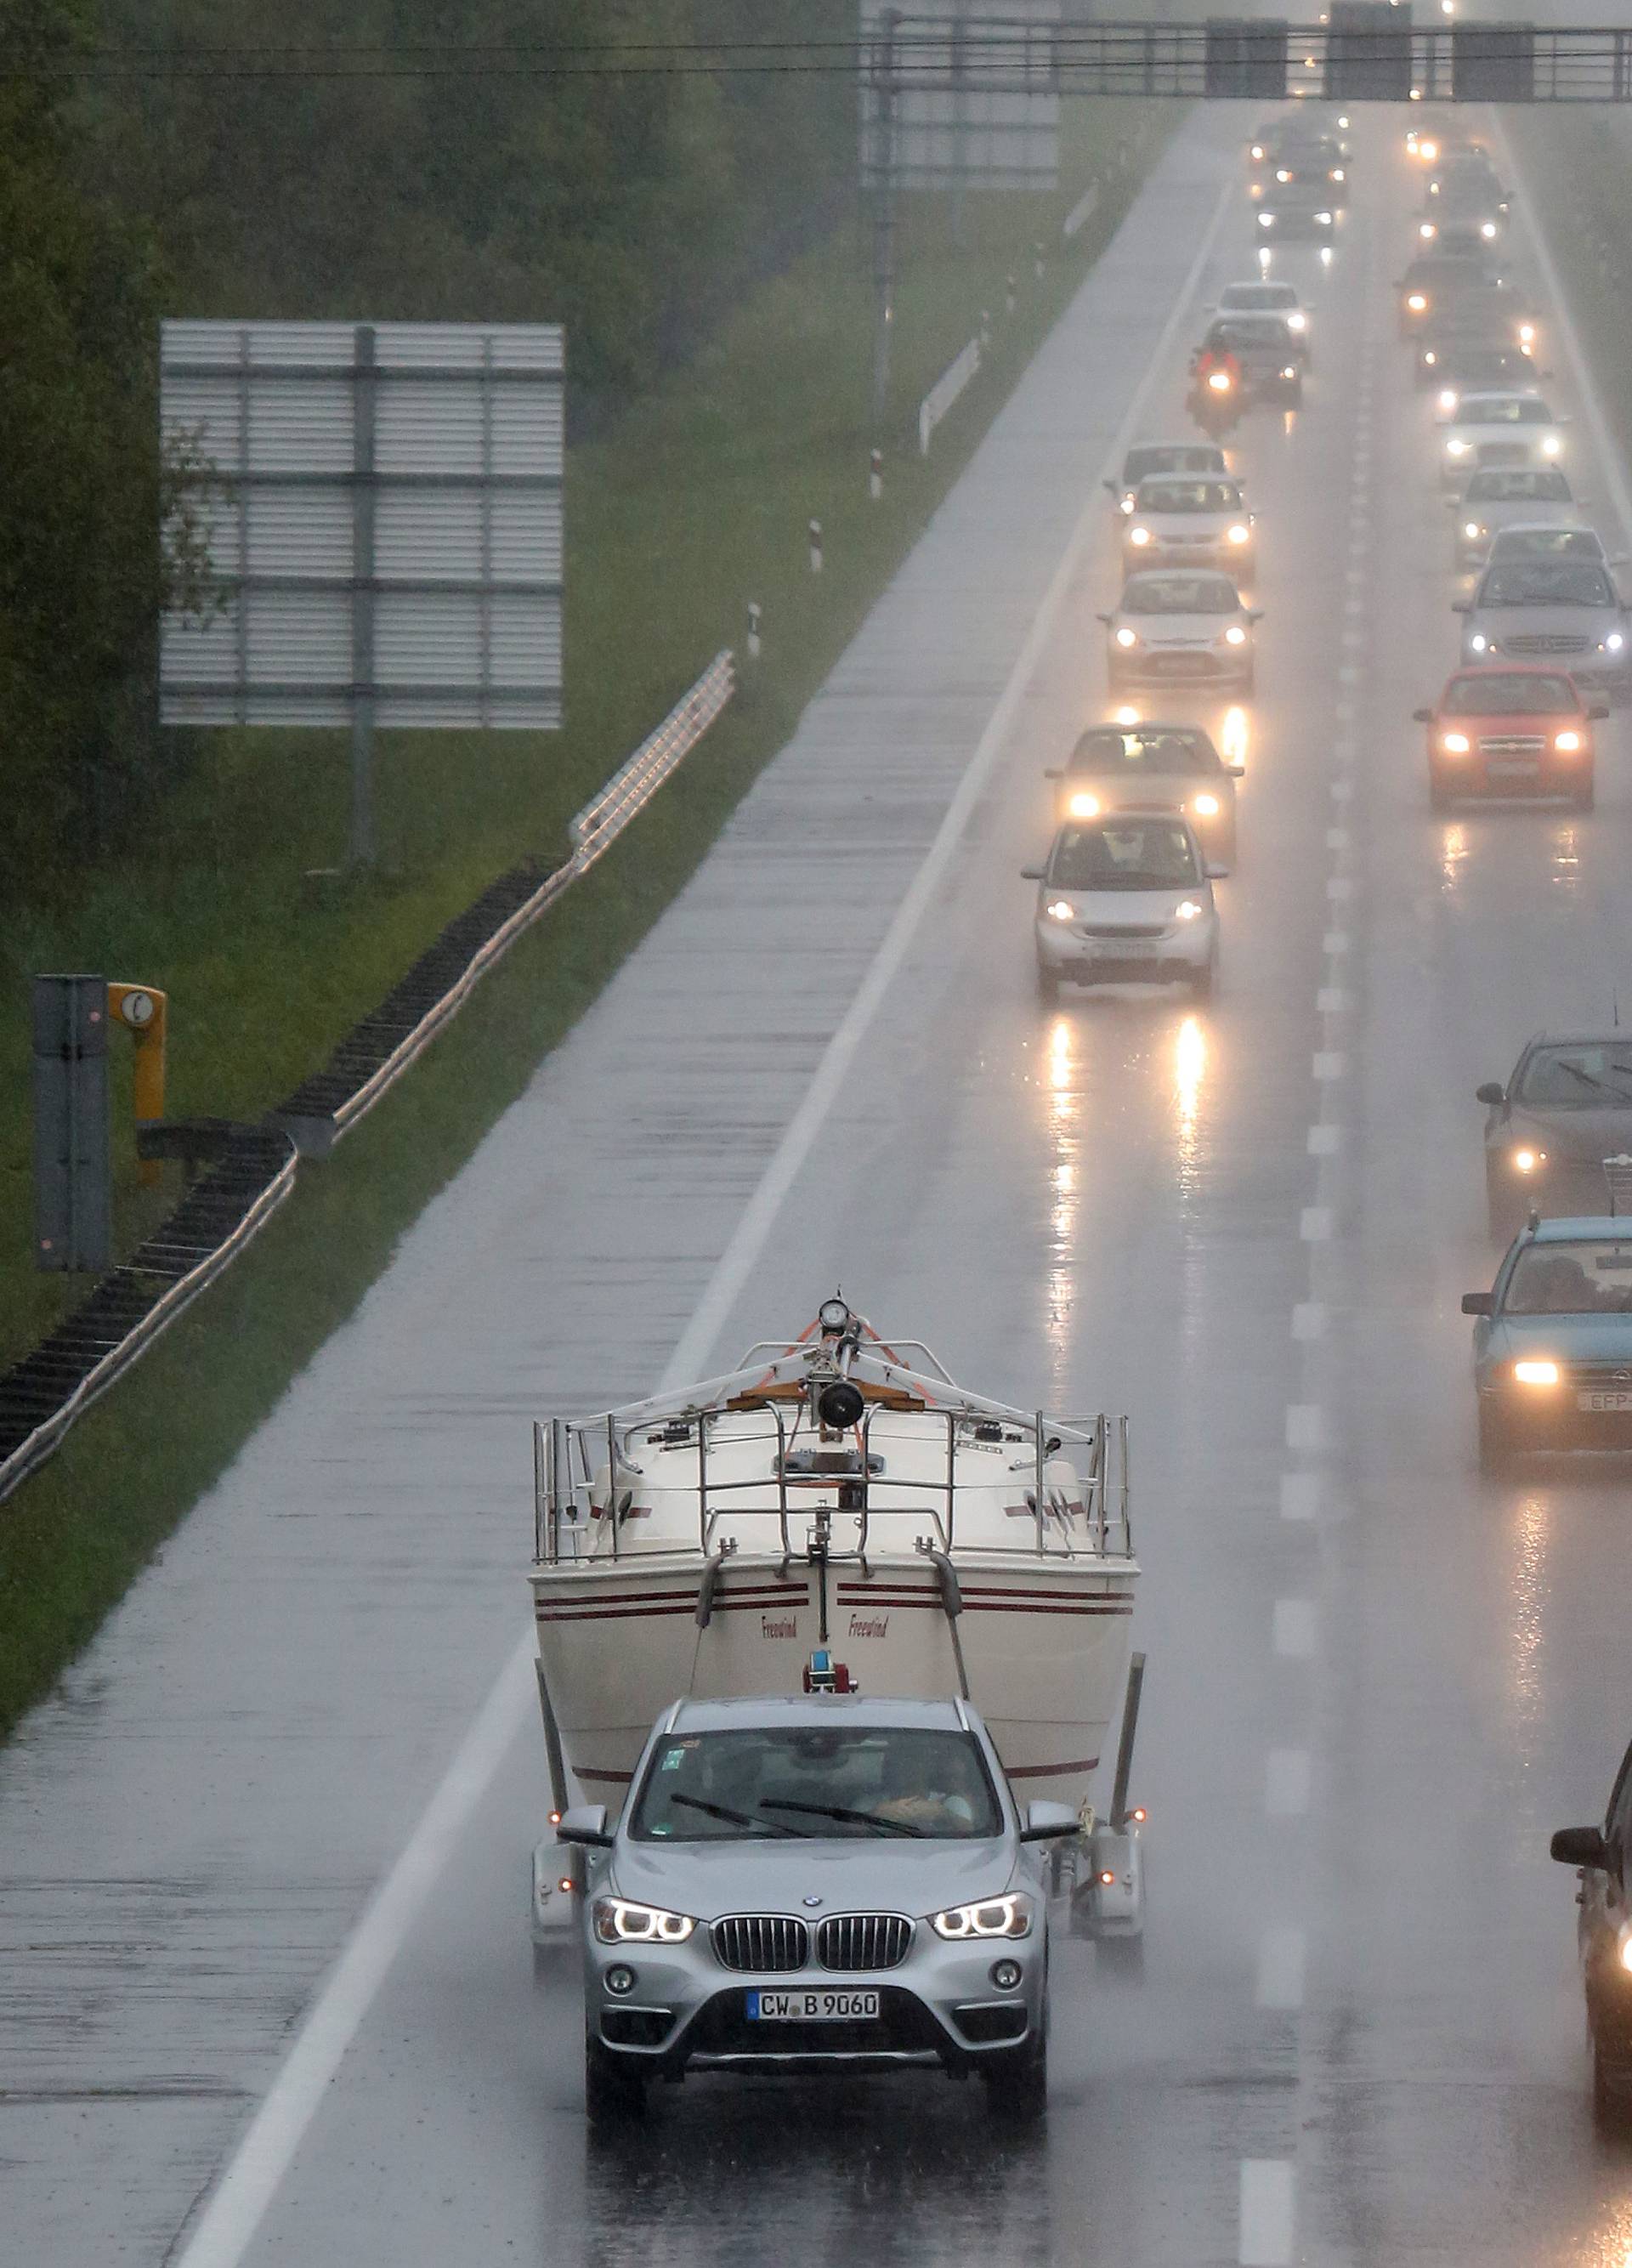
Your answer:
[174,160,1233,2268]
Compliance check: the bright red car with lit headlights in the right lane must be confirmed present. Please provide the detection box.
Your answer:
[1412,662,1609,812]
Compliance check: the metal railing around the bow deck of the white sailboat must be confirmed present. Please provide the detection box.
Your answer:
[533,1379,1133,1565]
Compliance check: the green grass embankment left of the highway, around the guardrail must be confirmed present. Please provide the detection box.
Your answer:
[0,105,1165,1731]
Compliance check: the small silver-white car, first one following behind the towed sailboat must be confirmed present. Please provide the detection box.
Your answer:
[1023,812,1224,1001]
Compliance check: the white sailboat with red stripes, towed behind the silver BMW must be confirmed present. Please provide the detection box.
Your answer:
[530,1300,1138,1814]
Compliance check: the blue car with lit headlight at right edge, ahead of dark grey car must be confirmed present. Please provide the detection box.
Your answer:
[1462,1213,1632,1472]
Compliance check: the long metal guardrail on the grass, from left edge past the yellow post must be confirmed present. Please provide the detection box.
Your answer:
[0,651,737,1501]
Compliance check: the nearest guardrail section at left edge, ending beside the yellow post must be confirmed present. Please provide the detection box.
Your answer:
[0,1127,297,1501]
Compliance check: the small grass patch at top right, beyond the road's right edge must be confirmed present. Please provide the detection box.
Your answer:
[1503,106,1632,454]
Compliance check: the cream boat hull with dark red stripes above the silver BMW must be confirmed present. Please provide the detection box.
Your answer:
[533,1551,1138,1806]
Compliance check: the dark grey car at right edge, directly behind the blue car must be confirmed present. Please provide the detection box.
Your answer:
[1478,1032,1632,1239]
